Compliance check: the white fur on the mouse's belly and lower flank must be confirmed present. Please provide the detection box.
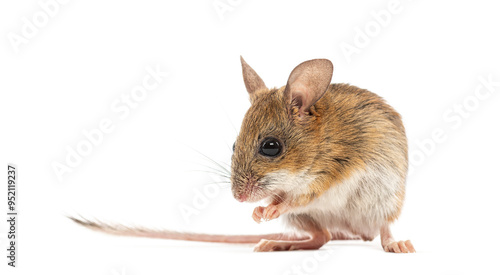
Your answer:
[284,166,405,239]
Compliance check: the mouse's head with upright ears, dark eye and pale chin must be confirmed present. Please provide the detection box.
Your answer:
[231,58,333,202]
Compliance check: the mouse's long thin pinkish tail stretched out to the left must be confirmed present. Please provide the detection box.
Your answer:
[68,217,300,244]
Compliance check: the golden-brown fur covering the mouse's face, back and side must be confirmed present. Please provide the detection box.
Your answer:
[232,84,408,216]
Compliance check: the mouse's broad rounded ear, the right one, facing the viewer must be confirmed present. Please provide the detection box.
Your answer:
[284,59,333,116]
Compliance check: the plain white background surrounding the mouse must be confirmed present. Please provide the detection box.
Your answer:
[0,0,500,275]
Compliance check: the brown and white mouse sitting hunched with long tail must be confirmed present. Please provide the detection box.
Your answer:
[70,56,416,253]
